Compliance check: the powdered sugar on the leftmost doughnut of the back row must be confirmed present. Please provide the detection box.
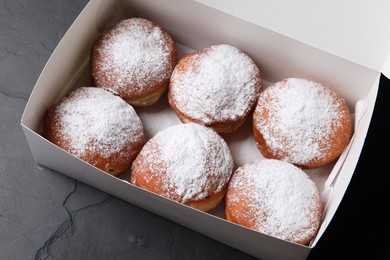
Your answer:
[95,18,173,93]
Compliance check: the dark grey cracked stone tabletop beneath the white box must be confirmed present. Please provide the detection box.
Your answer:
[0,0,390,259]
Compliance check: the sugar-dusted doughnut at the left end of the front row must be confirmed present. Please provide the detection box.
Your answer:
[43,86,145,176]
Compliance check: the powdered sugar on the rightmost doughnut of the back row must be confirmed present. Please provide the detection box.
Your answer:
[255,78,343,164]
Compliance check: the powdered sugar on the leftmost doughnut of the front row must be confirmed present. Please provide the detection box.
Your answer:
[50,87,143,158]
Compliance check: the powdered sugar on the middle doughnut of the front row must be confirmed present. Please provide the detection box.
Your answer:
[141,123,233,203]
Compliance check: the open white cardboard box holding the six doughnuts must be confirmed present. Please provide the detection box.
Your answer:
[21,0,390,259]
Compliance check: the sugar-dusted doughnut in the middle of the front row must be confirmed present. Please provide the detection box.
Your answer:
[130,123,234,212]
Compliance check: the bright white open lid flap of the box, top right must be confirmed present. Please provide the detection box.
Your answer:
[197,0,390,72]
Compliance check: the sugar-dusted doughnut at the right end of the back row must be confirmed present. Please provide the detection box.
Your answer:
[253,78,352,169]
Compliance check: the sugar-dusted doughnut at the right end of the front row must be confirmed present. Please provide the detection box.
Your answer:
[225,159,323,245]
